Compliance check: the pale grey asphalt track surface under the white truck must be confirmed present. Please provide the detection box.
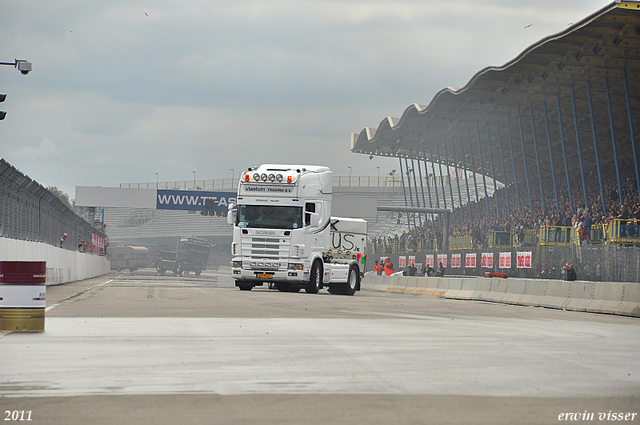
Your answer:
[0,270,640,424]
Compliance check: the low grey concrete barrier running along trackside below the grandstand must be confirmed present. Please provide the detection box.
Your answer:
[361,274,640,317]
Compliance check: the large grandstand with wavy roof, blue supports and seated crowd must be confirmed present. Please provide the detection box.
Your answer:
[351,1,640,282]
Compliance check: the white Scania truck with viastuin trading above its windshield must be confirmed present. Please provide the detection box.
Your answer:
[227,164,367,295]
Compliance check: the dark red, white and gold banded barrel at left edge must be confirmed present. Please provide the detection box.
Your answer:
[0,261,47,332]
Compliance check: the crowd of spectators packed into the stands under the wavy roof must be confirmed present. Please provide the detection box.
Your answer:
[374,155,640,250]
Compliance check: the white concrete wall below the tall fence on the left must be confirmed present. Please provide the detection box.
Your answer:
[0,238,110,285]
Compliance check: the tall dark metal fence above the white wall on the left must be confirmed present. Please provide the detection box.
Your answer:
[0,159,106,250]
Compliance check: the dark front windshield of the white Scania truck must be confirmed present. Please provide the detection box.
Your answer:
[236,205,302,229]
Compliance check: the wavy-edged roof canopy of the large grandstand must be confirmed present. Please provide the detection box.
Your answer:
[351,1,640,184]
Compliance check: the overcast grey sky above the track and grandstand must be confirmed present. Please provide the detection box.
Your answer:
[0,0,610,198]
